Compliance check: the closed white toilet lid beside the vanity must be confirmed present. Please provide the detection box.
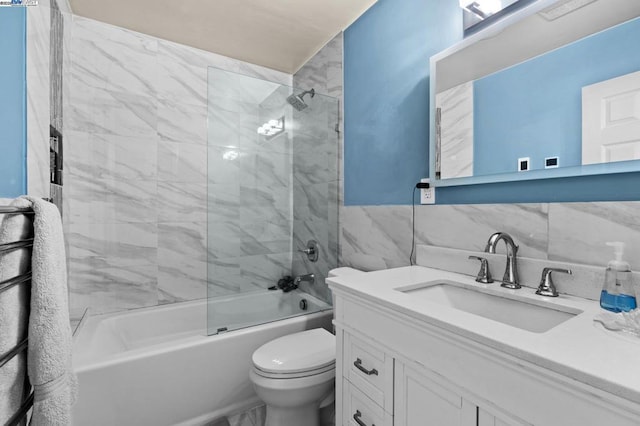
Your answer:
[253,328,336,374]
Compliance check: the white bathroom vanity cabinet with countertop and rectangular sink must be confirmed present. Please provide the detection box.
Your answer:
[327,266,640,426]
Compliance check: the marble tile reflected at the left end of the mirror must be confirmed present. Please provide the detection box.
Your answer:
[436,82,473,179]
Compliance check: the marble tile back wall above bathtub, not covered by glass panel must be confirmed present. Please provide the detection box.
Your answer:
[59,16,291,316]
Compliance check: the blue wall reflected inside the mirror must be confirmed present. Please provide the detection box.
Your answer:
[473,19,640,175]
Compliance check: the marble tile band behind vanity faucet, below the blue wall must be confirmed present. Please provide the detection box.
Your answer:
[341,202,640,292]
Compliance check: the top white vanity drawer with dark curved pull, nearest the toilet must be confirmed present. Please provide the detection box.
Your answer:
[344,333,393,413]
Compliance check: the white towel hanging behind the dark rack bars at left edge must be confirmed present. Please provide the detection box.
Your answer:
[0,198,32,424]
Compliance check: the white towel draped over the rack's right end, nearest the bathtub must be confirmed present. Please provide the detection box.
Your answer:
[24,197,77,426]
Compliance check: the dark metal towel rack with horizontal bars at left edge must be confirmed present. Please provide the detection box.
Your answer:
[0,206,34,426]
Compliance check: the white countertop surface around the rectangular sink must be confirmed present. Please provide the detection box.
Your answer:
[327,266,640,404]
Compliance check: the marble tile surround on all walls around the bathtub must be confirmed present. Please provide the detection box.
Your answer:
[28,7,342,318]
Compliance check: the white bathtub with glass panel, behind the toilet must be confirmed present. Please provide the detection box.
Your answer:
[73,291,333,426]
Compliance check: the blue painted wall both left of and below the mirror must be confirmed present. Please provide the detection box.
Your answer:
[344,0,640,205]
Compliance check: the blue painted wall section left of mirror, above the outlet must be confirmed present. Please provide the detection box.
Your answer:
[344,0,462,205]
